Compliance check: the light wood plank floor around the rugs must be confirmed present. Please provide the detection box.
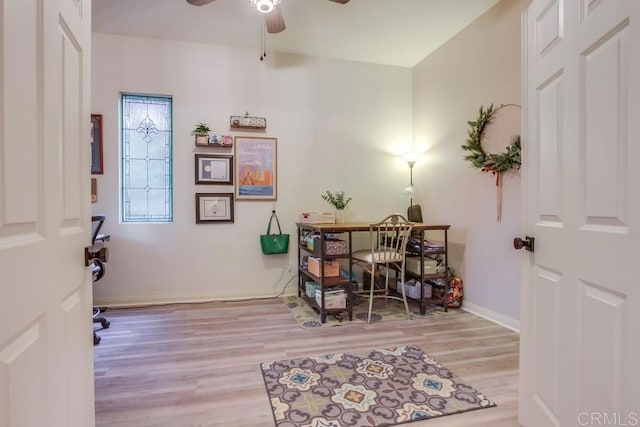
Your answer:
[95,298,519,427]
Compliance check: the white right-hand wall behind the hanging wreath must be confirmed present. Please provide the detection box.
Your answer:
[413,0,529,326]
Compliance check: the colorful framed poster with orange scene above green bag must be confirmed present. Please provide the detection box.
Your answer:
[234,136,278,200]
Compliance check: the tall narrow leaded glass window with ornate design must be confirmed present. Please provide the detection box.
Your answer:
[120,94,173,222]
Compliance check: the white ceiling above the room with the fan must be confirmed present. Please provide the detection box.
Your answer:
[92,0,499,67]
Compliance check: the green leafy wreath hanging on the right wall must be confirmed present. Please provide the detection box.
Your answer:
[462,104,522,175]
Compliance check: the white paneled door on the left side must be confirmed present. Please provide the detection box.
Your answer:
[0,0,94,427]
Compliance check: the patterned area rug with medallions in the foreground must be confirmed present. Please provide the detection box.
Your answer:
[261,346,495,427]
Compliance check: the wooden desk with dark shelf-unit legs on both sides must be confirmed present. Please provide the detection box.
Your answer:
[296,222,450,323]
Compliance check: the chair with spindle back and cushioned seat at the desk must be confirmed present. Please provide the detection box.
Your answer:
[351,214,413,323]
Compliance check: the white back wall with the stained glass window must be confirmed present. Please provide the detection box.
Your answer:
[92,34,412,305]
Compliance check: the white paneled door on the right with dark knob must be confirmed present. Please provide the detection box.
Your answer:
[520,0,640,427]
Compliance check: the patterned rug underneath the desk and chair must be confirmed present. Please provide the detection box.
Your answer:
[282,295,448,329]
